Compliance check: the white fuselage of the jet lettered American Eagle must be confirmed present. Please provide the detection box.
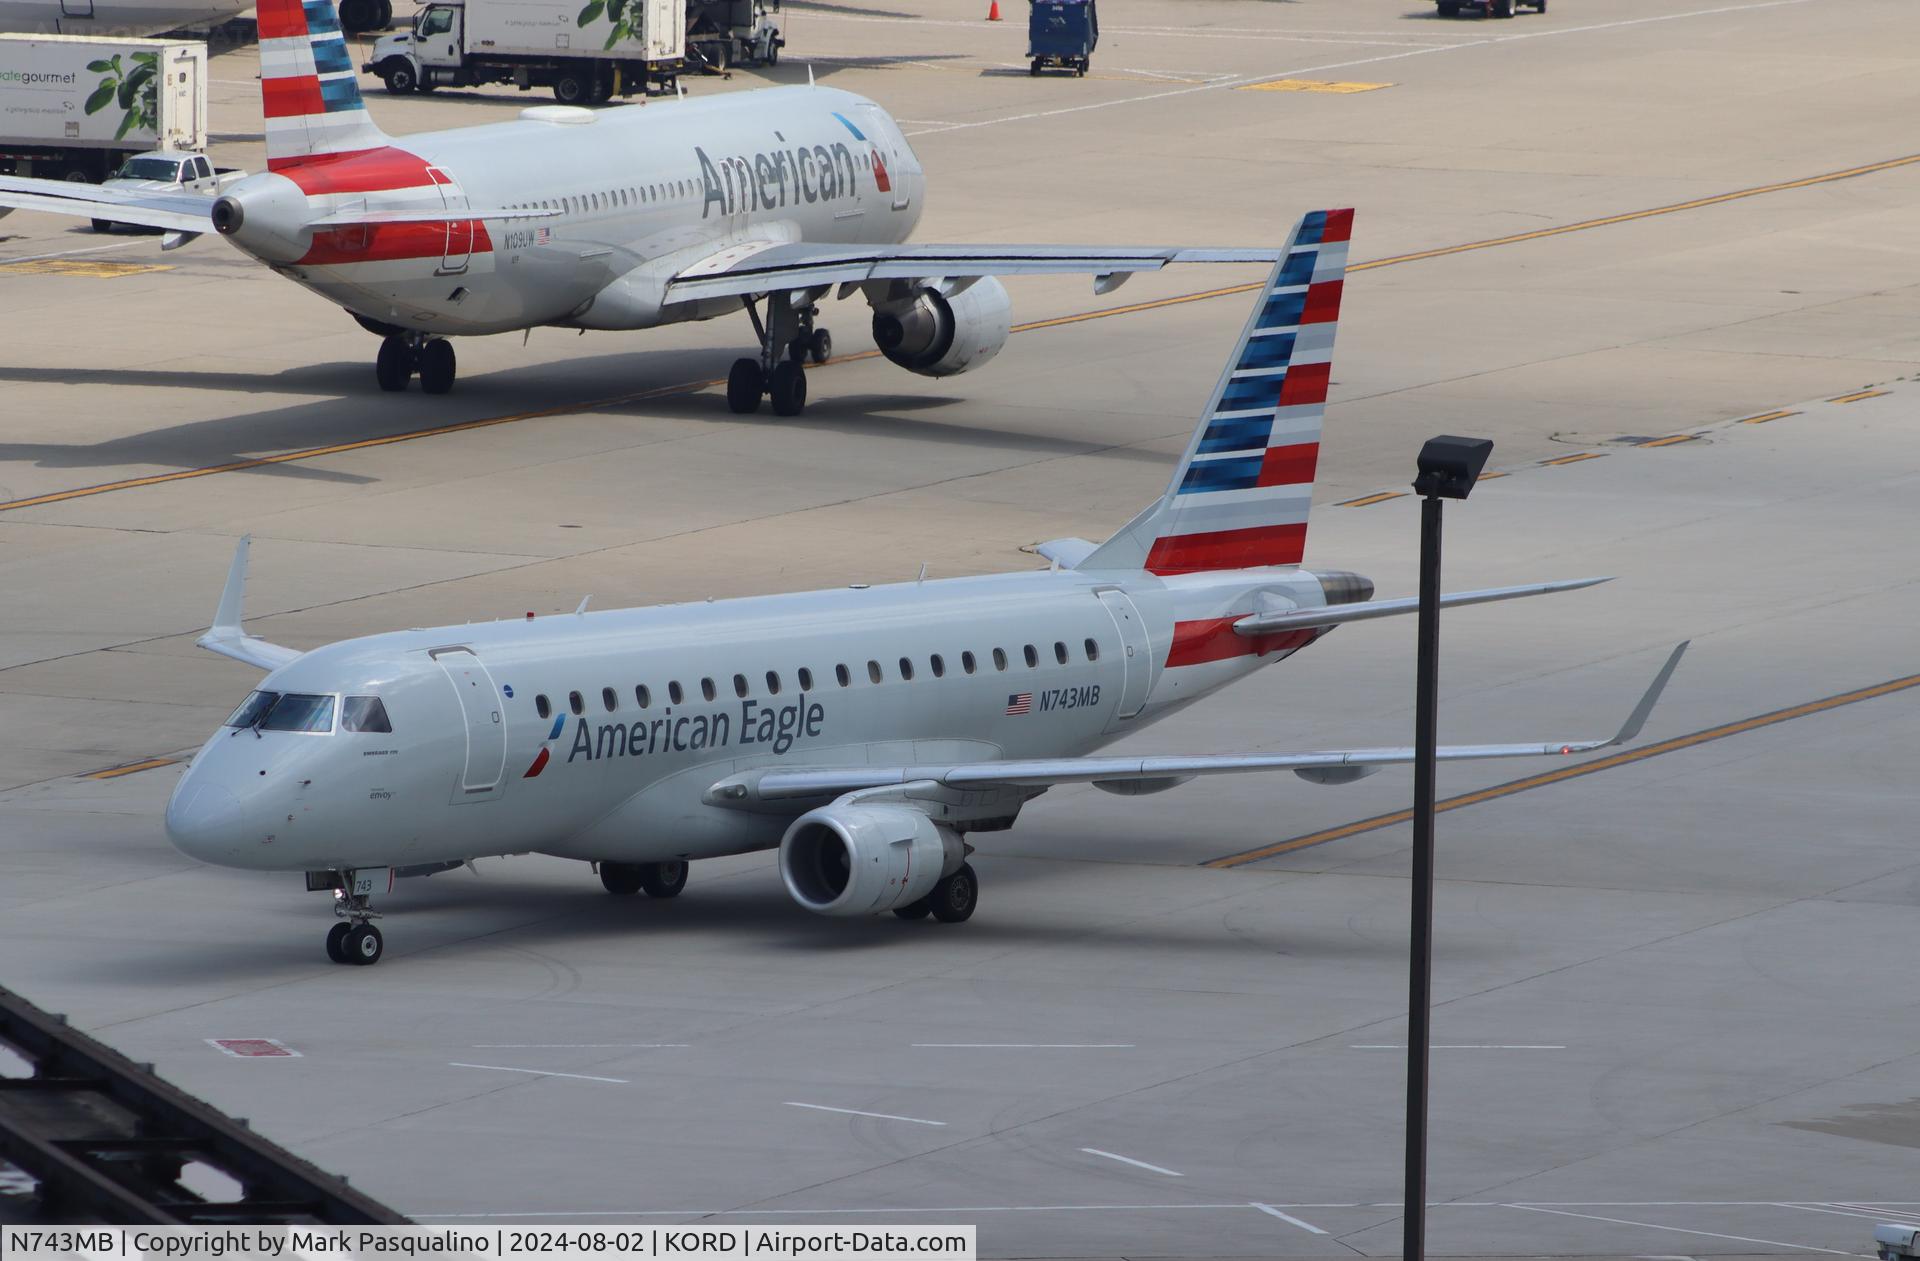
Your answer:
[167,568,1325,869]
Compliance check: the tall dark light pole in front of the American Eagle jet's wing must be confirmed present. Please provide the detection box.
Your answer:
[1404,436,1494,1261]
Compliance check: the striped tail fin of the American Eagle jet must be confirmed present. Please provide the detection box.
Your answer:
[1073,209,1354,574]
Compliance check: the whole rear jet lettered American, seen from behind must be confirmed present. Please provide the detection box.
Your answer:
[0,0,1305,416]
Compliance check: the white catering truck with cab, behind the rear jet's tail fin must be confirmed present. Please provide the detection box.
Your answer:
[361,0,687,106]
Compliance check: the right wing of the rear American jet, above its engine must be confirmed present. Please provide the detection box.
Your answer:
[666,242,1281,301]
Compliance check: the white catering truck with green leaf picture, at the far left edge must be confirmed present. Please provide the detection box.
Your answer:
[0,35,207,184]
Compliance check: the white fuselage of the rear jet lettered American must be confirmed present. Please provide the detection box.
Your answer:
[217,86,924,334]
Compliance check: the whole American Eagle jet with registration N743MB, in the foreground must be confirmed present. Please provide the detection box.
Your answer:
[167,209,1684,964]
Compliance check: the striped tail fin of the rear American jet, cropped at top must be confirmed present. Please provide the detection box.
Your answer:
[257,0,388,171]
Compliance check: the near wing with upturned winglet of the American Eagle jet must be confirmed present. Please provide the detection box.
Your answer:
[707,643,1688,808]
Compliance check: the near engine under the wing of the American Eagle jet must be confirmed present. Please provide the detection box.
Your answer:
[780,802,964,916]
